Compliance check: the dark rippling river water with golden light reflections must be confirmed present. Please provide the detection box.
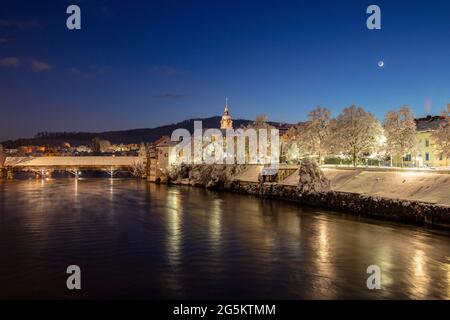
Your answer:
[0,179,450,299]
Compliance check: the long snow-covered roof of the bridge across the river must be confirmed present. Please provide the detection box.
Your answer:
[4,156,140,168]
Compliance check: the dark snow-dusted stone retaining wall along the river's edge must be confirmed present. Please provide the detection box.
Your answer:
[168,165,450,230]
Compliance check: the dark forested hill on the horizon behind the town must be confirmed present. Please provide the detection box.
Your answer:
[0,116,288,148]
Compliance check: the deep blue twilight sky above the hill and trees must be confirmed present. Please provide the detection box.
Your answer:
[0,0,450,140]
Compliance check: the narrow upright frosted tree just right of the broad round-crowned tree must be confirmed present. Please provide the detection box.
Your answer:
[384,106,416,167]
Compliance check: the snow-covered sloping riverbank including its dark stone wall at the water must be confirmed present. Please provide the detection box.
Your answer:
[168,165,450,230]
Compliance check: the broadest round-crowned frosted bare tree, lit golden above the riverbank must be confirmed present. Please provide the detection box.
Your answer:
[331,105,383,167]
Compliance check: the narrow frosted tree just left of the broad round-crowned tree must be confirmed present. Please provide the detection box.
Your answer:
[301,106,331,164]
